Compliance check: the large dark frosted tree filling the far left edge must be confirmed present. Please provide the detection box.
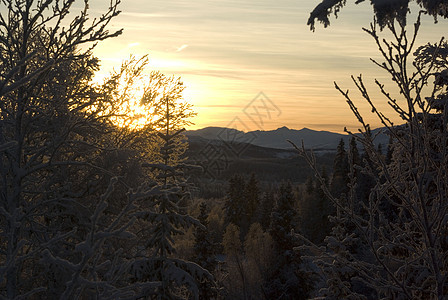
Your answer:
[0,0,150,299]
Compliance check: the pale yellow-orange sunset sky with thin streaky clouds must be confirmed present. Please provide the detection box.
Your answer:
[91,0,447,132]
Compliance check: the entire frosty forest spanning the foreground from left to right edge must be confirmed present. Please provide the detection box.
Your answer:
[0,0,448,300]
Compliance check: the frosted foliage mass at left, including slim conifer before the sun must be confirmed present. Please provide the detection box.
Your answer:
[0,0,209,299]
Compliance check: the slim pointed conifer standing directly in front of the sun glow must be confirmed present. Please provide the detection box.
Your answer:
[132,82,213,299]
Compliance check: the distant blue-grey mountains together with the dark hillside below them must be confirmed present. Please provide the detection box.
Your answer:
[186,127,389,198]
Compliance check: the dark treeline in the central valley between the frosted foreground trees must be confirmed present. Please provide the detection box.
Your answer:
[184,135,390,299]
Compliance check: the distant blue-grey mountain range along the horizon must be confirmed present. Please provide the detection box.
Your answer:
[186,126,389,151]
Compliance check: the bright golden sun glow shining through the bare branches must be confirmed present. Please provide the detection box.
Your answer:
[95,57,195,130]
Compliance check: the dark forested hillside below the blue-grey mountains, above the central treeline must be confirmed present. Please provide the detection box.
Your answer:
[186,135,334,198]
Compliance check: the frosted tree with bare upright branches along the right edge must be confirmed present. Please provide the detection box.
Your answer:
[301,6,448,299]
